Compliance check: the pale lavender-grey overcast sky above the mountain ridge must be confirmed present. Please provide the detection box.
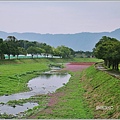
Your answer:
[0,1,120,34]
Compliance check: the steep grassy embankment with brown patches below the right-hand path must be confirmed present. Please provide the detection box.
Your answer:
[81,66,120,118]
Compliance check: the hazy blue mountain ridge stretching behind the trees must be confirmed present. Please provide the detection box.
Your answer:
[0,28,120,51]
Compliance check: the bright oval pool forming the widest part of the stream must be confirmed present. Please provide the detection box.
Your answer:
[28,74,70,93]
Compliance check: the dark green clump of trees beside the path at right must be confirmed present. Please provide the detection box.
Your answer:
[93,36,120,70]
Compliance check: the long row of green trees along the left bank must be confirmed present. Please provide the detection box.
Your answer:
[0,36,74,59]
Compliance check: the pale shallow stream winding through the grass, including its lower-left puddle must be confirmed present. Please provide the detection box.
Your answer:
[0,69,71,114]
